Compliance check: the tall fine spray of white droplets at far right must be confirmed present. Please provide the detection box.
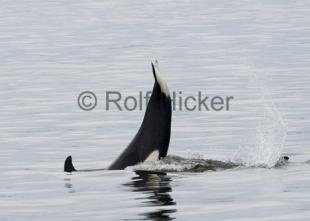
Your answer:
[233,75,287,168]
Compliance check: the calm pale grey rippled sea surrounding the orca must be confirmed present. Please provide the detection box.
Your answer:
[0,0,310,221]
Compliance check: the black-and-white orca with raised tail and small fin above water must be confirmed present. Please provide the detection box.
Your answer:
[64,61,172,172]
